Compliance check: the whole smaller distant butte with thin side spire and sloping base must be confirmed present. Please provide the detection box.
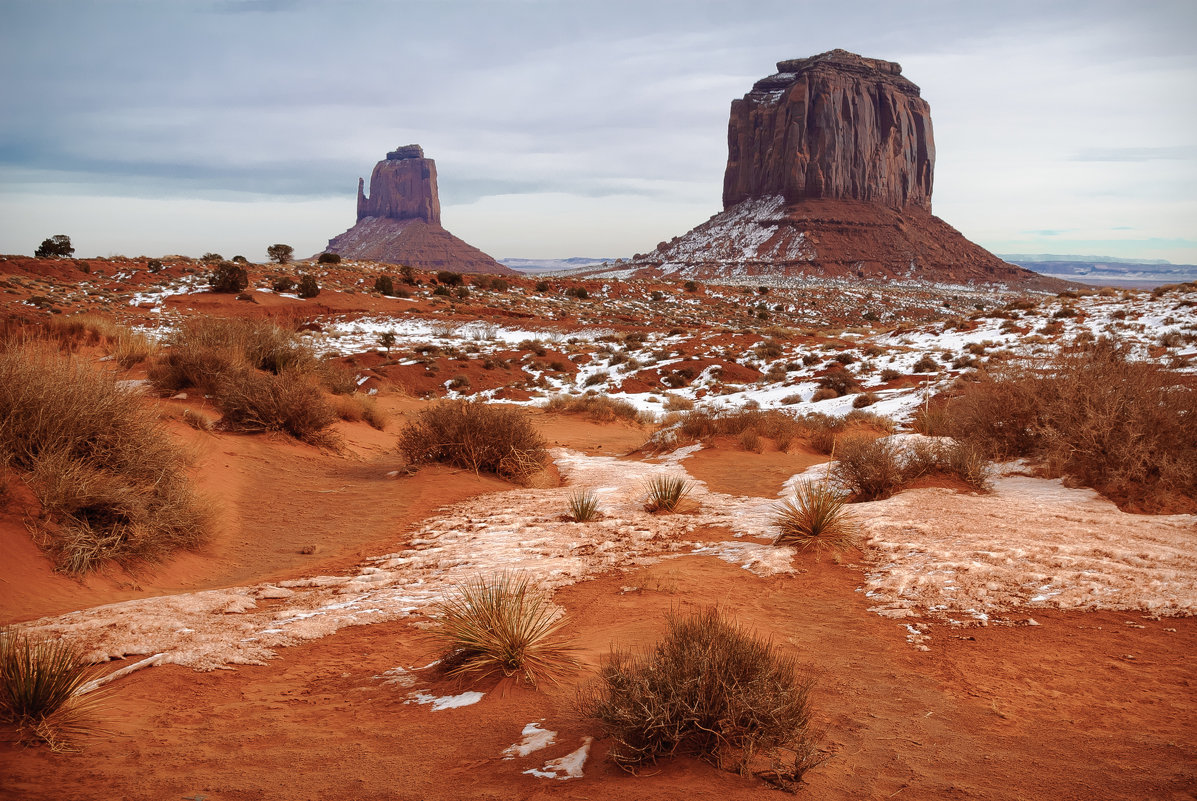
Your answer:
[326,145,517,275]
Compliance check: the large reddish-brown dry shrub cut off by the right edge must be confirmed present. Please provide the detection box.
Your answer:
[949,340,1197,511]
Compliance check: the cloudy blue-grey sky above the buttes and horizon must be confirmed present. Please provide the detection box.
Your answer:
[0,0,1197,263]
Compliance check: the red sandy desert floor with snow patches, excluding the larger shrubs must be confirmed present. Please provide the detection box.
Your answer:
[0,259,1197,801]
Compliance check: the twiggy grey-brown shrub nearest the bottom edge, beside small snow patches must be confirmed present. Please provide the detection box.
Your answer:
[578,608,820,782]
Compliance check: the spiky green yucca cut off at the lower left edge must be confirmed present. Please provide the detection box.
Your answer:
[0,629,104,751]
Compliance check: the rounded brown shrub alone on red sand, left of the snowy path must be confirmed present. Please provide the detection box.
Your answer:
[399,400,548,481]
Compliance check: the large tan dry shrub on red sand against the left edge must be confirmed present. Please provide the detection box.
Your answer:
[0,344,209,574]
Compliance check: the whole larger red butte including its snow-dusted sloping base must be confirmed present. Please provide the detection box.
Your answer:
[618,50,1064,289]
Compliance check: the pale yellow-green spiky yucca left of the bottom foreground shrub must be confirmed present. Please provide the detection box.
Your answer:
[433,572,578,686]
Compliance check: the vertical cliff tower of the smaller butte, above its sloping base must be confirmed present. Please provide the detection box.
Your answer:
[358,145,440,225]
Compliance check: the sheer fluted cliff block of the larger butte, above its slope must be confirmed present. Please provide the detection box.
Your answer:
[723,50,935,210]
